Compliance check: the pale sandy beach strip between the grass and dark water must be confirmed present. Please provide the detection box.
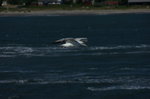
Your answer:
[0,9,150,16]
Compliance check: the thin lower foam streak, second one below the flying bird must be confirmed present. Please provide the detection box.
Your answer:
[0,51,150,58]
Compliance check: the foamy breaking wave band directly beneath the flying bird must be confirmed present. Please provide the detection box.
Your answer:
[0,44,150,57]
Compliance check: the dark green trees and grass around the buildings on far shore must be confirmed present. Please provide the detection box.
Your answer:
[0,0,150,12]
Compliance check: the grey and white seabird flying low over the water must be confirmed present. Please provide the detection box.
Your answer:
[53,38,88,48]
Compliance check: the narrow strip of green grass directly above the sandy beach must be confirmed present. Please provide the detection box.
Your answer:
[0,4,150,12]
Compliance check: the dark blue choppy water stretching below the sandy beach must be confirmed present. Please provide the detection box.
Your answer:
[0,14,150,99]
